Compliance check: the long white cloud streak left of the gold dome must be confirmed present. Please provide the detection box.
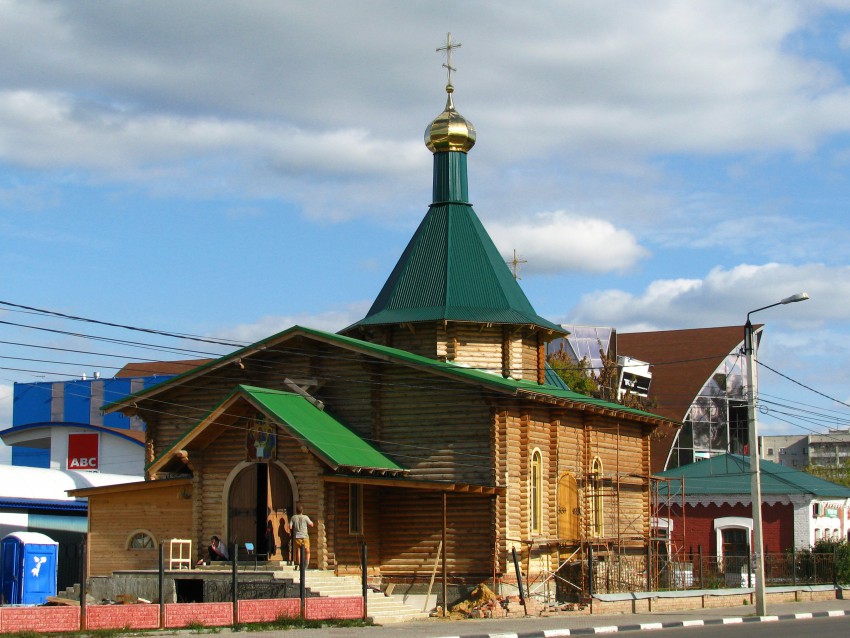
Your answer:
[0,91,424,176]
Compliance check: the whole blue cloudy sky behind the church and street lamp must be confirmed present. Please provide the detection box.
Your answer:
[0,0,850,459]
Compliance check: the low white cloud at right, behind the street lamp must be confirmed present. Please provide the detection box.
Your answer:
[562,263,850,434]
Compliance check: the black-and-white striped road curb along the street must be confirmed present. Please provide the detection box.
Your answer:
[430,609,850,638]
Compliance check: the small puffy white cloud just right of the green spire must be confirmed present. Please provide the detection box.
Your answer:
[488,211,649,274]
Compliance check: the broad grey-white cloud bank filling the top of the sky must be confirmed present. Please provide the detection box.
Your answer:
[0,0,850,217]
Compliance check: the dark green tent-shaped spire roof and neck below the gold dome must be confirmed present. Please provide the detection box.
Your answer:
[346,152,565,334]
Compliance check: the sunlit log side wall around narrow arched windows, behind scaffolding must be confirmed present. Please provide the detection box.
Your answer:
[493,404,650,567]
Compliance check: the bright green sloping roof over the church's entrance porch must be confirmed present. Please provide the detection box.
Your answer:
[239,385,404,472]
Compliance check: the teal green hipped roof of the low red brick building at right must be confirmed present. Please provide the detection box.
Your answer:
[657,454,850,498]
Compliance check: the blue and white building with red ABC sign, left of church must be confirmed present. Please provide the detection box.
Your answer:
[0,361,204,588]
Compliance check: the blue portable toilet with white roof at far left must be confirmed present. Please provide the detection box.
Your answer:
[0,532,59,605]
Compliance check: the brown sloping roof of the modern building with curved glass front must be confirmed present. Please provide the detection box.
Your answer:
[617,326,744,472]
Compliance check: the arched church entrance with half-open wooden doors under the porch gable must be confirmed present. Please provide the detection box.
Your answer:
[227,463,293,559]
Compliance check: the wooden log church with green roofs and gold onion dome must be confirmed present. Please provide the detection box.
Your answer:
[79,50,669,600]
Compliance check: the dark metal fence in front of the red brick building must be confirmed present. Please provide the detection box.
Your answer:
[592,552,836,593]
